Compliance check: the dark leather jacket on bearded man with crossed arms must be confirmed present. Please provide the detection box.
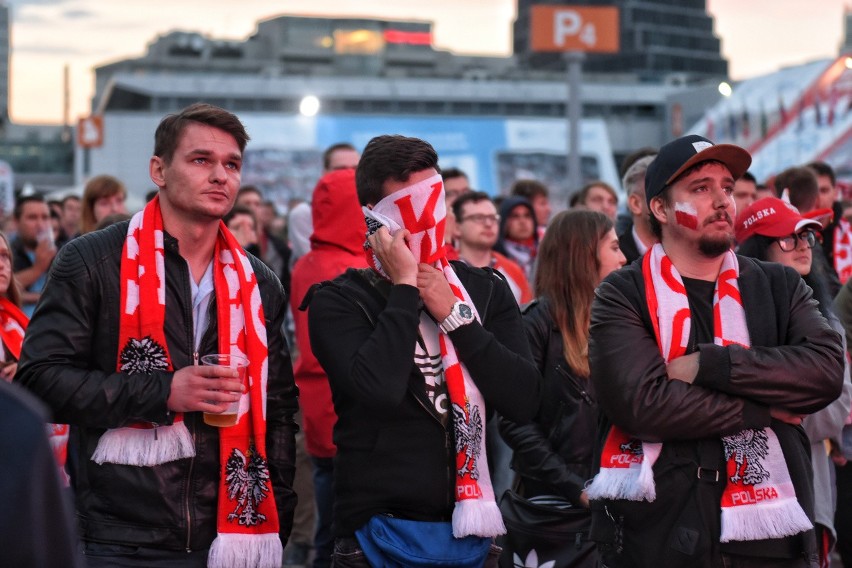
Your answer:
[589,256,844,568]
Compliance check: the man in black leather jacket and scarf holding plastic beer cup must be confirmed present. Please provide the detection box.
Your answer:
[16,104,297,568]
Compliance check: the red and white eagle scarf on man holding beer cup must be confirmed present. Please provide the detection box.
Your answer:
[92,197,283,568]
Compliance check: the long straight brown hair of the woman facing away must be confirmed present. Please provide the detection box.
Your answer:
[534,209,613,377]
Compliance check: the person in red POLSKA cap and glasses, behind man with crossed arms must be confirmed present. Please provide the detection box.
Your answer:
[736,197,852,565]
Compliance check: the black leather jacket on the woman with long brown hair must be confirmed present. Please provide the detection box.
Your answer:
[500,300,597,506]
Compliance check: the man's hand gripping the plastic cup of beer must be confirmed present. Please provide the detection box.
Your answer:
[166,365,242,413]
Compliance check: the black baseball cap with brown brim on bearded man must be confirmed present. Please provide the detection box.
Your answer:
[645,134,751,205]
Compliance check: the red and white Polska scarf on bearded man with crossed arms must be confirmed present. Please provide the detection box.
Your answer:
[588,243,813,542]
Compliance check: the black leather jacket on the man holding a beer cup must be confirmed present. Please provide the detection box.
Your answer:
[15,222,298,550]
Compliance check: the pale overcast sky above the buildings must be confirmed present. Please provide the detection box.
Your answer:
[8,0,844,123]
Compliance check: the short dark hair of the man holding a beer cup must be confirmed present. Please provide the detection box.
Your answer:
[154,103,249,164]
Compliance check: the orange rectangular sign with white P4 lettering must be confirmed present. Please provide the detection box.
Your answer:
[530,5,619,53]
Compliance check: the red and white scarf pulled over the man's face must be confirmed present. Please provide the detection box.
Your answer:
[364,175,506,538]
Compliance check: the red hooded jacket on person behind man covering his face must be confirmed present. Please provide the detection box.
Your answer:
[290,169,367,458]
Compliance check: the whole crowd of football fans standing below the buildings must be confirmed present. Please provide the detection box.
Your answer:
[5,103,852,568]
